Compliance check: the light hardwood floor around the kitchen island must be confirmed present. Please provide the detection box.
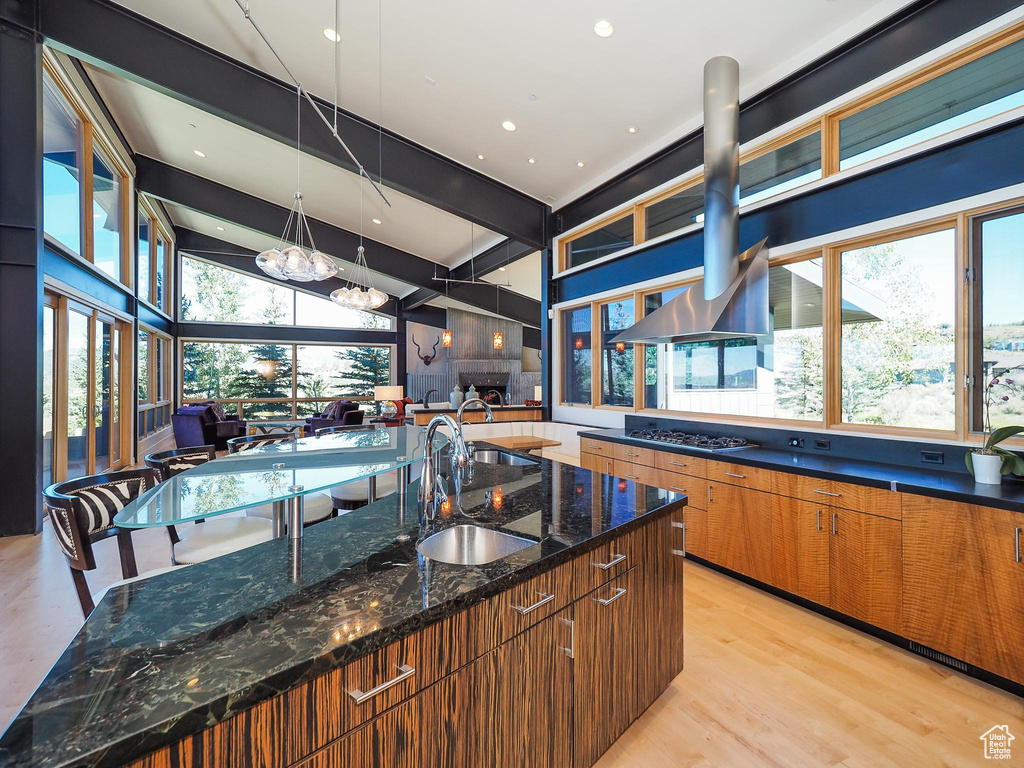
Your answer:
[0,524,1024,768]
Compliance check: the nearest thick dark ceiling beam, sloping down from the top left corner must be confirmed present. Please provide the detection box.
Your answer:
[39,0,550,247]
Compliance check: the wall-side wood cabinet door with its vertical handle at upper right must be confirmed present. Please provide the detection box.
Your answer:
[771,496,831,605]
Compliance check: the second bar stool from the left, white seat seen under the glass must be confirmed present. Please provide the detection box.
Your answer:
[145,445,273,564]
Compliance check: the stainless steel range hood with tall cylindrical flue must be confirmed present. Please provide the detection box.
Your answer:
[612,56,768,344]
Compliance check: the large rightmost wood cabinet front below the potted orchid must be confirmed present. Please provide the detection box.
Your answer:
[903,496,1024,682]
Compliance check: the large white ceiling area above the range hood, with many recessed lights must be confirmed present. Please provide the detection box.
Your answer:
[112,0,909,208]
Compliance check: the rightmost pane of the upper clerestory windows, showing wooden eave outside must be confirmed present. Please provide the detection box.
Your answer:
[839,35,1024,170]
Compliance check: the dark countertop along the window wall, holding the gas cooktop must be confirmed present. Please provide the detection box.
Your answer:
[586,429,1024,512]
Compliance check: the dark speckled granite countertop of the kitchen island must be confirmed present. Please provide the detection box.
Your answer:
[0,443,686,768]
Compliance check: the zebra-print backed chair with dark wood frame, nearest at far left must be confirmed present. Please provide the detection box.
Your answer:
[43,469,182,617]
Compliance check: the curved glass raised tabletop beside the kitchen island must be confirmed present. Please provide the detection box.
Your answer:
[114,427,447,528]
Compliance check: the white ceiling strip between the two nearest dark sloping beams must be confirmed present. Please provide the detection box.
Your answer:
[86,64,504,274]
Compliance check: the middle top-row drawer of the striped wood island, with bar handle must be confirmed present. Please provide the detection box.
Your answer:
[481,562,575,649]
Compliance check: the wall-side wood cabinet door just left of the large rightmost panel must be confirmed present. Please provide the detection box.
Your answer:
[828,507,903,633]
